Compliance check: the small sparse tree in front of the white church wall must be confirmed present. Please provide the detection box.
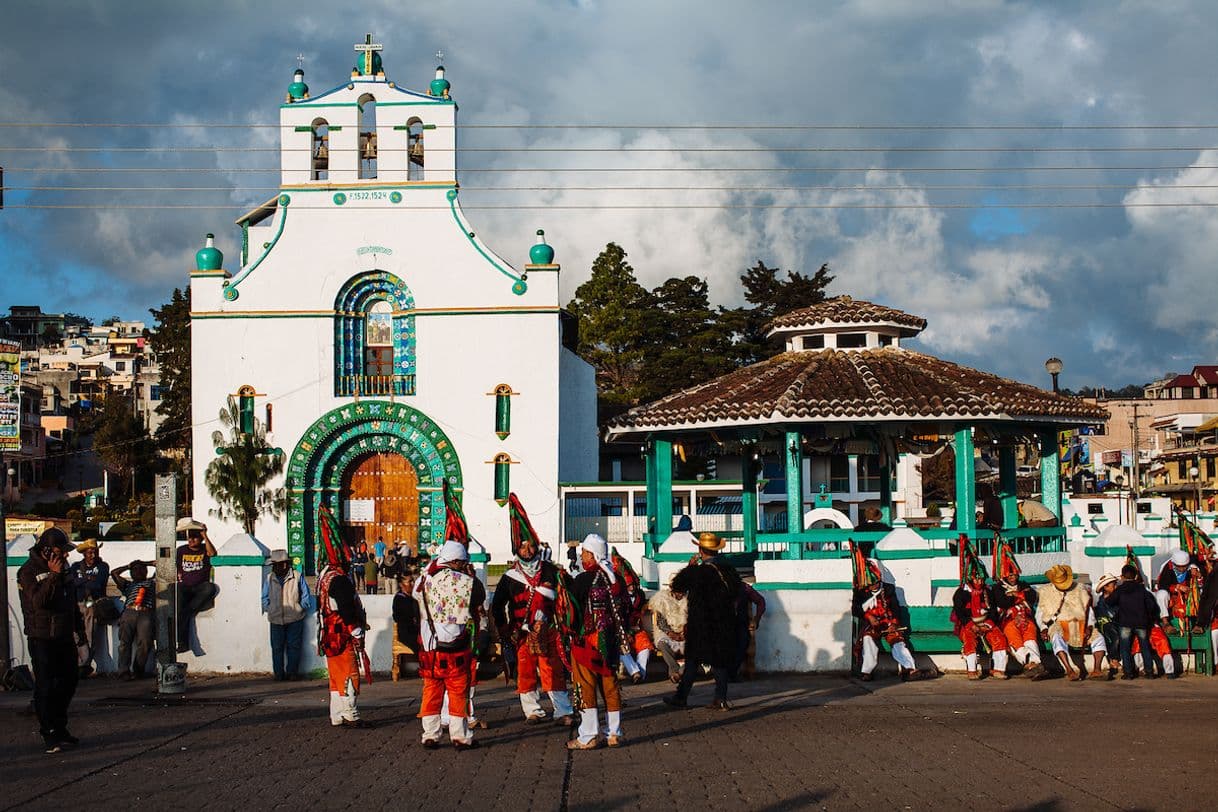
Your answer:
[203,396,287,536]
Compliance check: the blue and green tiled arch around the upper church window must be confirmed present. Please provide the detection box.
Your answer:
[334,270,417,397]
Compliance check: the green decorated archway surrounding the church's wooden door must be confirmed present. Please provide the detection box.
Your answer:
[286,401,462,573]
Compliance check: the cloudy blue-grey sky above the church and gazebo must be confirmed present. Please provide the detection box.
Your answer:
[0,0,1218,387]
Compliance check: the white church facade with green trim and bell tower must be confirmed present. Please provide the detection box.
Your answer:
[191,37,597,571]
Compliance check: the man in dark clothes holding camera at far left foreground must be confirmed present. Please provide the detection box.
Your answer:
[17,527,85,752]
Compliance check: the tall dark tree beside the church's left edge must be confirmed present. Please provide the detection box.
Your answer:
[149,287,190,460]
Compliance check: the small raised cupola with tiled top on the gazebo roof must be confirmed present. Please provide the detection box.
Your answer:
[769,296,926,352]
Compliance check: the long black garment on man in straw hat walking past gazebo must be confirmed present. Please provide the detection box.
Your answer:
[672,556,741,668]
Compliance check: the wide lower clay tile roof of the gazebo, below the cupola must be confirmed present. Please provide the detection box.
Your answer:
[609,347,1108,439]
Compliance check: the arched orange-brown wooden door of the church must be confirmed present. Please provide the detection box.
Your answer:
[342,452,419,551]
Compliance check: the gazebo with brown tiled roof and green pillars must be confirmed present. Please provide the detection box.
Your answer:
[609,296,1107,558]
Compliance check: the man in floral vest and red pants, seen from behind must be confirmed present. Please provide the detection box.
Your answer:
[414,542,486,750]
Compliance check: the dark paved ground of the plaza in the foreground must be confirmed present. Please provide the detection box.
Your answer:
[0,676,1218,811]
